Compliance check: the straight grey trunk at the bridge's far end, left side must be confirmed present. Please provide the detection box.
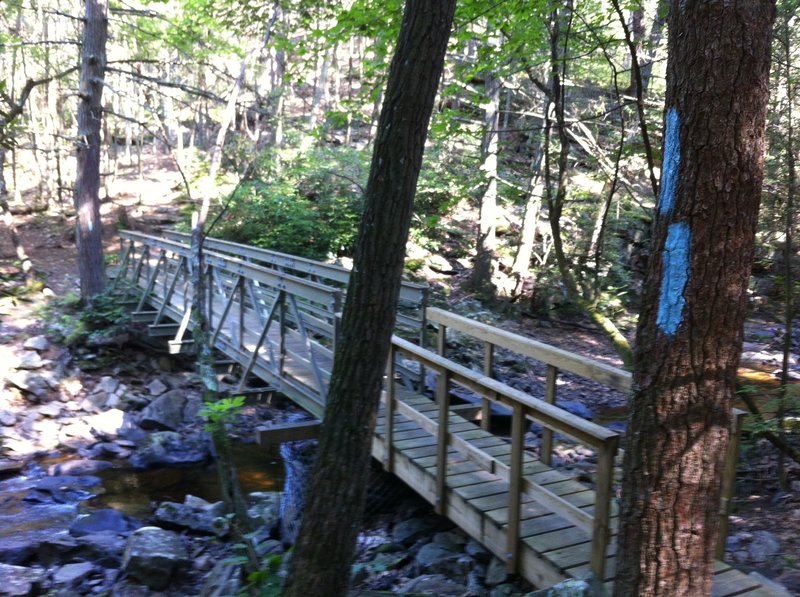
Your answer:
[75,0,108,300]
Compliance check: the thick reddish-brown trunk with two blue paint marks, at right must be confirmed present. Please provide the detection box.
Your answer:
[614,0,775,597]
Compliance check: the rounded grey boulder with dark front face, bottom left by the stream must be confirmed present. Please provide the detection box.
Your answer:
[122,527,190,591]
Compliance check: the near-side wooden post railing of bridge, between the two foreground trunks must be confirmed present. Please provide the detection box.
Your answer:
[384,337,619,578]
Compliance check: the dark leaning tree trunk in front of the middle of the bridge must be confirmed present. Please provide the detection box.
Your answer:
[284,0,455,597]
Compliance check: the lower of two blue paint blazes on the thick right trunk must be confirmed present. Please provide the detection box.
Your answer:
[656,222,692,337]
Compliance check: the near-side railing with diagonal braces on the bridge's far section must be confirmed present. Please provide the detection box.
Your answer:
[115,231,342,415]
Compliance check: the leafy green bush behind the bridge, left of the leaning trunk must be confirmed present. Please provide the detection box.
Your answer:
[215,148,366,259]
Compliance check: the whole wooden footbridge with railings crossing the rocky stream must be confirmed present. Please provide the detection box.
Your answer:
[109,232,774,597]
